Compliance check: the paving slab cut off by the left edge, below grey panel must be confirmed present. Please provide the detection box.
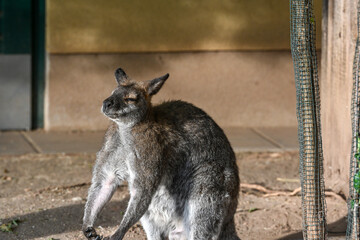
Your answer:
[0,132,35,155]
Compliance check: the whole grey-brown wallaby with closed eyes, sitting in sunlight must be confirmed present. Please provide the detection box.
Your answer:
[83,68,240,240]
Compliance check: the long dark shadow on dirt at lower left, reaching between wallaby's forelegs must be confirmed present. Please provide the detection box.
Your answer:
[0,198,128,240]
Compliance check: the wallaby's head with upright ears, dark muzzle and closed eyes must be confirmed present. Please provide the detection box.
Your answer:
[102,68,169,124]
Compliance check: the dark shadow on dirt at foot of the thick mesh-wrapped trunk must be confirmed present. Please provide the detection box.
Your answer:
[277,216,347,240]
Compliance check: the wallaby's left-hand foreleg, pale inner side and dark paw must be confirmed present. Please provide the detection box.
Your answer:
[83,172,117,240]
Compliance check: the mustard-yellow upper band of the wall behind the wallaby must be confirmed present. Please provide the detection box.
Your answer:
[47,0,321,53]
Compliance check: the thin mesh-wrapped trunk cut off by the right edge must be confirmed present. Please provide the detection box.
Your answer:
[346,1,360,239]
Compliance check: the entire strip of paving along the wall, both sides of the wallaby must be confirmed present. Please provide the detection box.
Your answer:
[0,127,298,155]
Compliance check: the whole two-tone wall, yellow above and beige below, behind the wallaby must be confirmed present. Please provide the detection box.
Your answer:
[45,0,321,130]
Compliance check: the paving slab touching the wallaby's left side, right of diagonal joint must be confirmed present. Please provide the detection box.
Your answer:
[26,131,105,153]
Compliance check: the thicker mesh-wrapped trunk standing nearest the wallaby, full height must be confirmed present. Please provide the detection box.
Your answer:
[290,0,327,239]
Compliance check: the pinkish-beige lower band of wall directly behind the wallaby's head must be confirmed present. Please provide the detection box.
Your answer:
[46,51,296,130]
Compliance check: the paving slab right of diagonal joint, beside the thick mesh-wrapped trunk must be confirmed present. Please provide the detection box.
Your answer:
[254,127,299,151]
